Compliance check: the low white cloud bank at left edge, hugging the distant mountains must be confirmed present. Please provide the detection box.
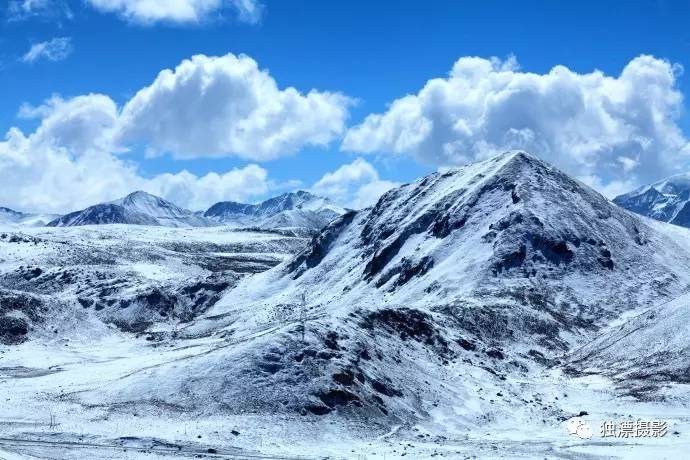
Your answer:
[0,108,271,213]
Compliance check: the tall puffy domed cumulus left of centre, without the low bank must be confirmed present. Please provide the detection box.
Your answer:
[118,54,351,161]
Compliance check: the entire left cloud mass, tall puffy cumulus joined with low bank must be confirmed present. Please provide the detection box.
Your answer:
[0,51,349,212]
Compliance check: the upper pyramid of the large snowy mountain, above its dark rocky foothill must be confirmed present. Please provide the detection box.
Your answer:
[210,152,688,328]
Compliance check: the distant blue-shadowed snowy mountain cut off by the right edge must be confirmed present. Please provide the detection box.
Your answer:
[613,174,690,227]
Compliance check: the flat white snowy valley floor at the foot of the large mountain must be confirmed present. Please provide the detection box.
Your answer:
[0,332,690,459]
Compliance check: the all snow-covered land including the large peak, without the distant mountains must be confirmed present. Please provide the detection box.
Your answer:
[0,154,690,459]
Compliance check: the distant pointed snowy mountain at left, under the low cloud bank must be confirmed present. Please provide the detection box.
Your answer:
[48,191,214,227]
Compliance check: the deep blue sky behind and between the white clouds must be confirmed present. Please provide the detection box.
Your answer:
[0,0,690,210]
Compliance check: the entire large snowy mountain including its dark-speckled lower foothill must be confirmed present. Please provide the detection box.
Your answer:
[72,152,690,429]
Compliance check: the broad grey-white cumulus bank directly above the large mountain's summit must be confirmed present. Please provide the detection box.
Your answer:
[341,56,690,194]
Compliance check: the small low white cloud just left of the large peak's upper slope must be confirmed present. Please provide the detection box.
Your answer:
[311,158,400,209]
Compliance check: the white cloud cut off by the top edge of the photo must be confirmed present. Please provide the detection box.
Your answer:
[87,0,263,24]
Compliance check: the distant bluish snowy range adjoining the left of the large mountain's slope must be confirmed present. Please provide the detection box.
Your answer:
[204,190,346,230]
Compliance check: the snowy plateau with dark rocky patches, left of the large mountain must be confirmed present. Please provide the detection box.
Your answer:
[0,225,307,343]
